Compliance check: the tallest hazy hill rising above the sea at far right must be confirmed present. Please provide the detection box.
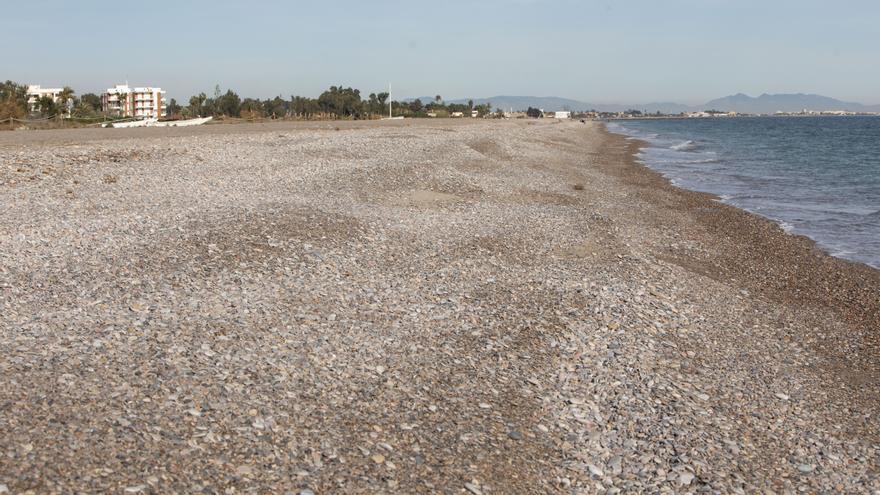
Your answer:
[704,93,880,113]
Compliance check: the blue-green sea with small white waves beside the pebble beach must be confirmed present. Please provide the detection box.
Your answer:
[607,117,880,268]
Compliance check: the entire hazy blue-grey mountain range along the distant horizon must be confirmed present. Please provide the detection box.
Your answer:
[410,93,880,114]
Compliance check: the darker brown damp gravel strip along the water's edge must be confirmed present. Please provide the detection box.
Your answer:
[602,125,880,381]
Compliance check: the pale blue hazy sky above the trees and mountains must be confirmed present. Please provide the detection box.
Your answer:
[0,0,880,104]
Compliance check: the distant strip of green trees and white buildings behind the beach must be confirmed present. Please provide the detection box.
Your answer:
[0,81,876,129]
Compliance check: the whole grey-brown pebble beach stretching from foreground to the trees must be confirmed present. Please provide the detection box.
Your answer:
[0,121,880,495]
